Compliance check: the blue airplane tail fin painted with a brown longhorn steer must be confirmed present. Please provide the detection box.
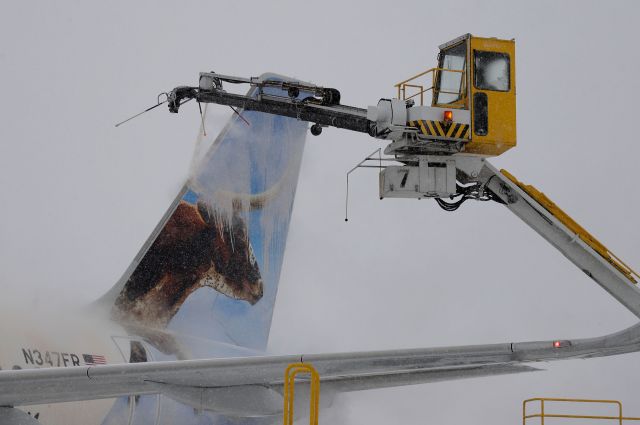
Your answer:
[102,75,307,349]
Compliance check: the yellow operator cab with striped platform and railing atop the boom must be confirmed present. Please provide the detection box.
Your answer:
[396,34,516,156]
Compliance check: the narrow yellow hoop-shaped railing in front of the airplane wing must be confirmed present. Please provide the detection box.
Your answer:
[283,363,320,425]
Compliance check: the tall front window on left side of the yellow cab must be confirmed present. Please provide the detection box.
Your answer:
[434,43,467,105]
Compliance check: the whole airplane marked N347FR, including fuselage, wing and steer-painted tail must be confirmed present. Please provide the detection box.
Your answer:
[0,78,640,424]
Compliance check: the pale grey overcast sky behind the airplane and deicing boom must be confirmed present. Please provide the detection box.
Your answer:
[0,0,640,425]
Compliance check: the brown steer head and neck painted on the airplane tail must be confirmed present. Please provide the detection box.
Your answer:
[112,201,263,328]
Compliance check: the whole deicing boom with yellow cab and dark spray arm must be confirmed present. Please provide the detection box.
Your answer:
[161,34,640,317]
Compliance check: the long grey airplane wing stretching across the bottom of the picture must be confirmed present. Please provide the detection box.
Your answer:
[0,324,640,415]
